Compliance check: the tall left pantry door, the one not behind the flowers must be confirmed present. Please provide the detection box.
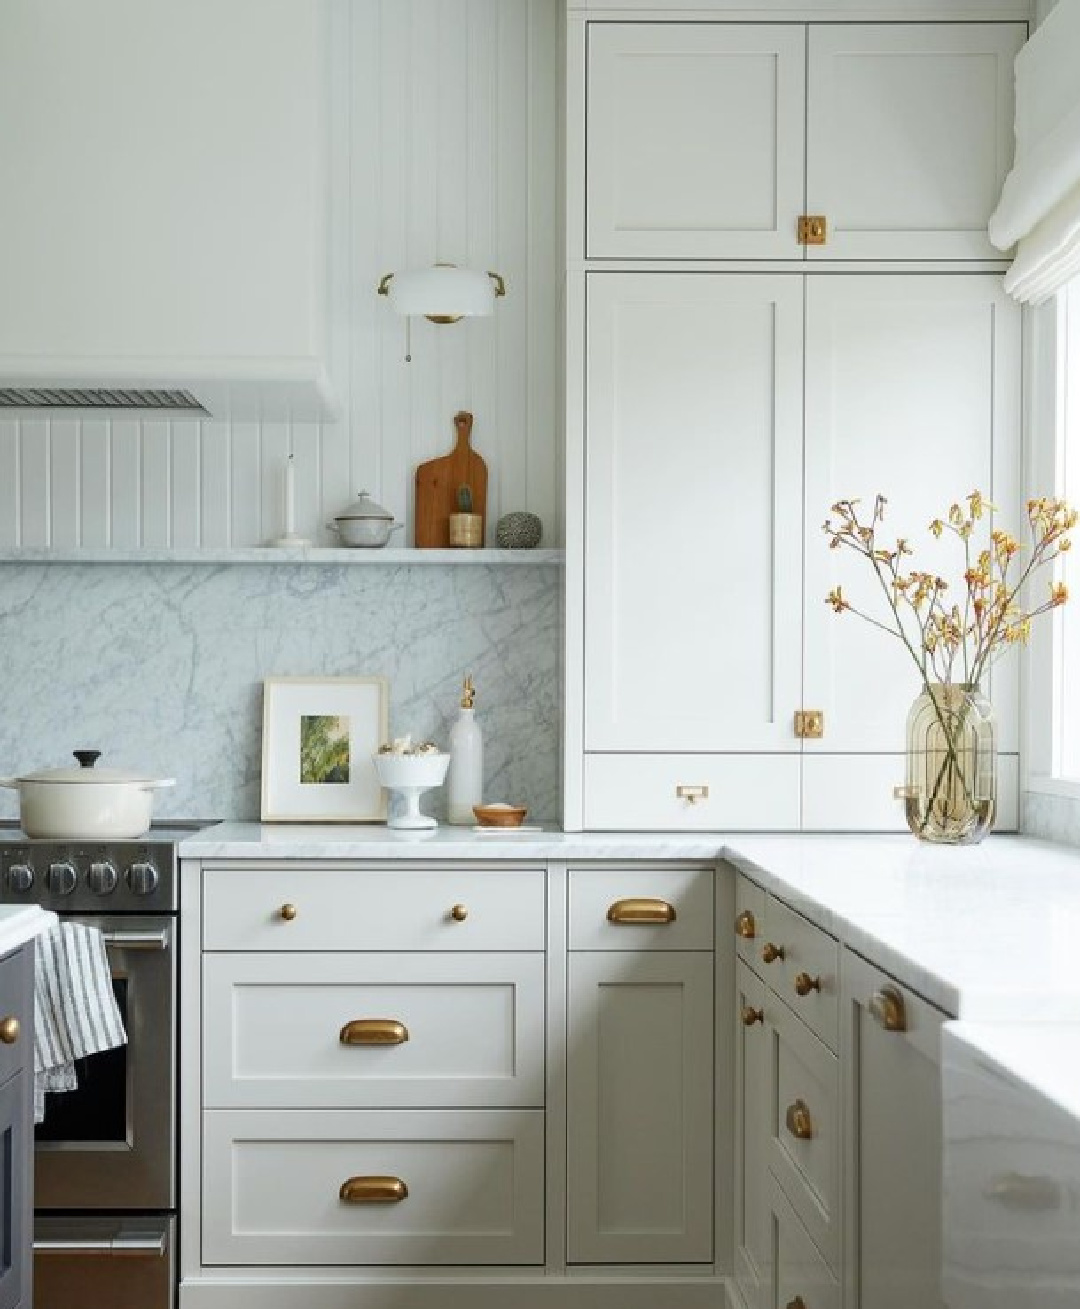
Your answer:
[584,274,802,759]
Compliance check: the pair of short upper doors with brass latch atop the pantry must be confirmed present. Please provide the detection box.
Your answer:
[584,22,1026,259]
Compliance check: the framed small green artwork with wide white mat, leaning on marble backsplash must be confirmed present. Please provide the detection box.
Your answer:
[262,677,390,822]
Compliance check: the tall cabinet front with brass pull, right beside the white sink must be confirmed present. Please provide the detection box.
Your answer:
[842,950,945,1309]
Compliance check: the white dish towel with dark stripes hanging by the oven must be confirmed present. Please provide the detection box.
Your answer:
[34,923,127,1123]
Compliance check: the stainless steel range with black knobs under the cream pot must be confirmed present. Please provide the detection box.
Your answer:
[0,823,202,1309]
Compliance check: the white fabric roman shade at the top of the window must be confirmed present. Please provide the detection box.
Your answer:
[988,0,1080,304]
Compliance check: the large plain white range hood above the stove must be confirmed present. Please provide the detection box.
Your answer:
[0,0,335,420]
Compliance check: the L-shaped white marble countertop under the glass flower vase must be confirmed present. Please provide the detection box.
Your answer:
[181,823,1080,1024]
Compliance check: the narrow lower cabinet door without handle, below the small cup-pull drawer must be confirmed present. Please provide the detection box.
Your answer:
[567,952,713,1263]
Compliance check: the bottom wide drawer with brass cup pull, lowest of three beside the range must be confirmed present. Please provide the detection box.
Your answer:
[203,1110,543,1266]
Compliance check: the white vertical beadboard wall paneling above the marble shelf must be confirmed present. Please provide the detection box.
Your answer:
[0,0,563,548]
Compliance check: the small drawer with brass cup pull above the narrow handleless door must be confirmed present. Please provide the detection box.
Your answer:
[569,868,716,950]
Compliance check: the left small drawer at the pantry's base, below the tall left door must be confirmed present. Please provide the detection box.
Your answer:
[583,754,800,827]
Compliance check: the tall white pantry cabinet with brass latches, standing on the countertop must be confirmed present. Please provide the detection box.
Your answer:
[564,0,1026,830]
